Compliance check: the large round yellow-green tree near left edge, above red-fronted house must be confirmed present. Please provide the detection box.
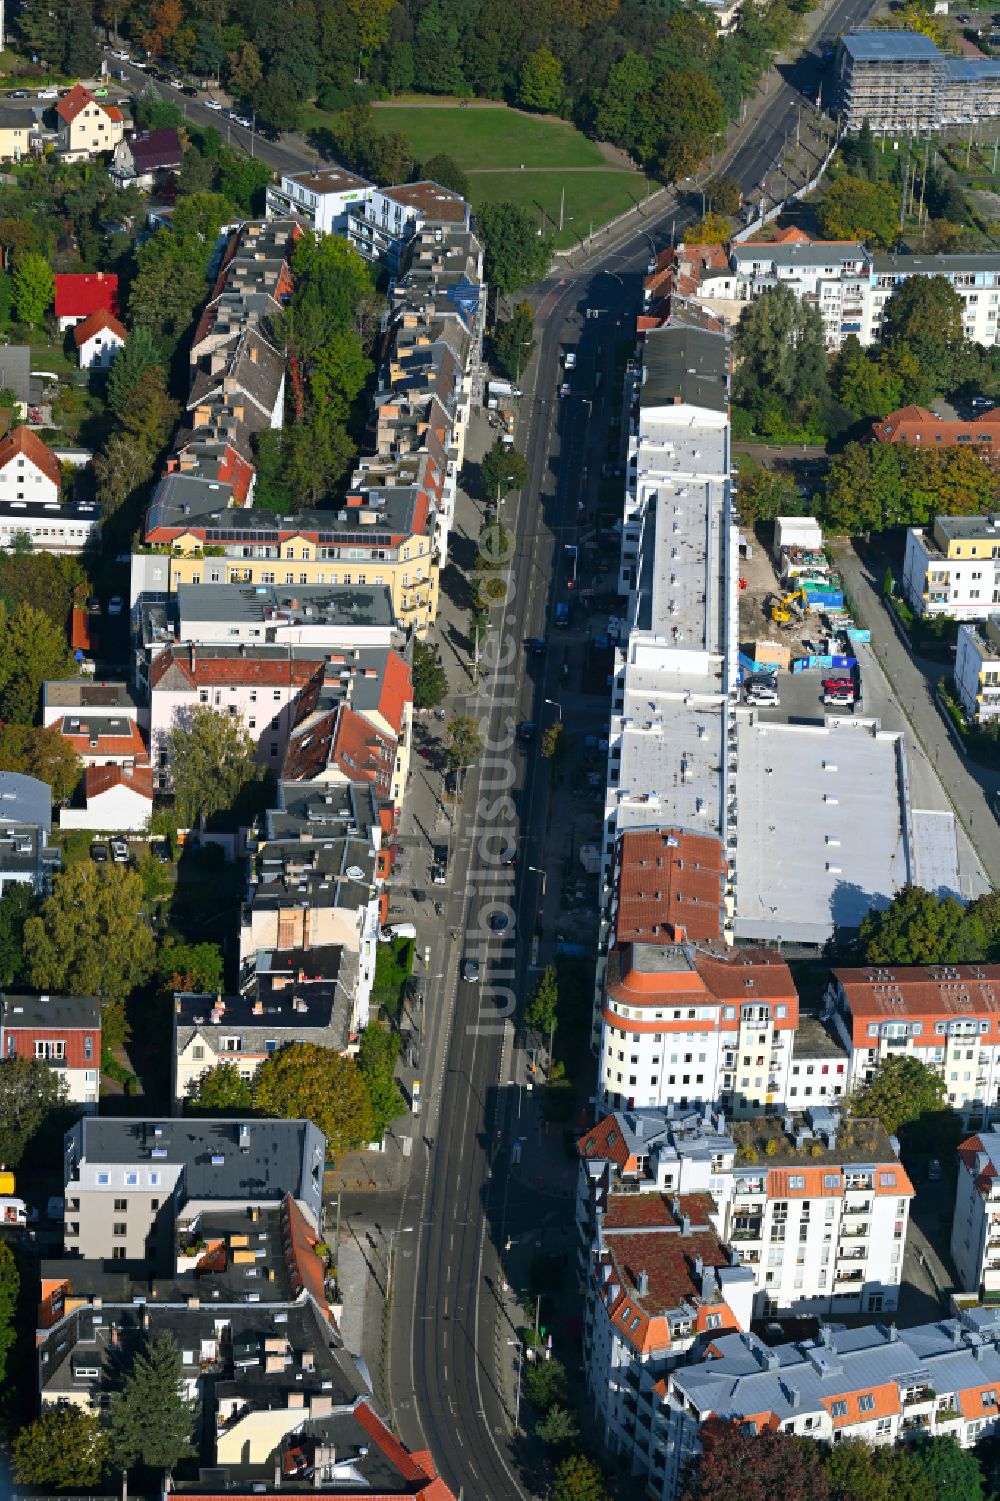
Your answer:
[24,860,156,1001]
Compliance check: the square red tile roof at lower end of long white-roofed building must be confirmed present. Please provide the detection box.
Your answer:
[616,829,724,943]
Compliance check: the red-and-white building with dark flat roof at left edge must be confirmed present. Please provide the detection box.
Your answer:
[0,994,101,1109]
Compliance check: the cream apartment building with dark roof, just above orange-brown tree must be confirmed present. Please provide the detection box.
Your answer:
[173,944,358,1115]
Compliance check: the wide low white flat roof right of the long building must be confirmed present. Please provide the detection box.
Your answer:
[734,710,908,944]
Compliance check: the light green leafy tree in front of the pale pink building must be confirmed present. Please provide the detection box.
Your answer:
[165,704,264,827]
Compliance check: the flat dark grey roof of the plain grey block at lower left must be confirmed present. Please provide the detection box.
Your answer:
[66,1115,326,1202]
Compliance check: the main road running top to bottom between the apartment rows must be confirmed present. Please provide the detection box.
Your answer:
[379,0,871,1501]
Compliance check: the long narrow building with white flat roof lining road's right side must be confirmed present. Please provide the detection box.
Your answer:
[595,310,737,1042]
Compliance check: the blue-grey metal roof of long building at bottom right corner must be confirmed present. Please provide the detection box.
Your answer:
[668,1309,1000,1421]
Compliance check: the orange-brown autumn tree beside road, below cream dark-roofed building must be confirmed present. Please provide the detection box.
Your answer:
[254,1042,375,1157]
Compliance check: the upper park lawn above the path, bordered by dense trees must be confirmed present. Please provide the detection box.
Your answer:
[364,105,604,171]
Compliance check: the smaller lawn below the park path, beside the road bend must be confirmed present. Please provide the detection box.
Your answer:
[470,167,658,251]
